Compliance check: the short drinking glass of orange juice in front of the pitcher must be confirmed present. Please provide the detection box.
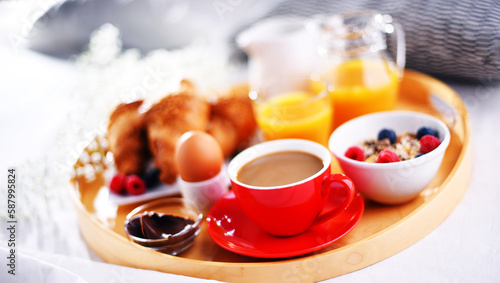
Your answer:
[250,80,333,146]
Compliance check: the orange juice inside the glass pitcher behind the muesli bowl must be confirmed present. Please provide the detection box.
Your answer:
[327,59,399,128]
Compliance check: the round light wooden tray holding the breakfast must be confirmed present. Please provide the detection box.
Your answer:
[70,71,472,282]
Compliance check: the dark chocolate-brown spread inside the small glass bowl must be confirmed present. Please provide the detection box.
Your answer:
[126,211,194,240]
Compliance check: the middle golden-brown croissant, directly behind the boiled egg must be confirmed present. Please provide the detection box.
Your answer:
[144,86,210,184]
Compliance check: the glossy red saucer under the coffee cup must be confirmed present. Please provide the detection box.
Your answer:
[207,192,365,258]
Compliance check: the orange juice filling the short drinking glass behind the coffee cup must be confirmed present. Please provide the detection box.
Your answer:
[254,91,332,146]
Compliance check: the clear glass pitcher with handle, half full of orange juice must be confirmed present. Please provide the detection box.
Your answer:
[306,10,405,129]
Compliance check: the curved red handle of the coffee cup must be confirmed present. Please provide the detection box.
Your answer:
[315,174,356,224]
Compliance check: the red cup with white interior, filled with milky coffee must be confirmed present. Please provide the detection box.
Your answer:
[228,139,356,236]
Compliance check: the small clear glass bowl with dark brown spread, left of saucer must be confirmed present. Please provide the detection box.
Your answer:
[125,198,203,255]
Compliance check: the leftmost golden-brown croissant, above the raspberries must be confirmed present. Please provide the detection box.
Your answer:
[107,101,151,175]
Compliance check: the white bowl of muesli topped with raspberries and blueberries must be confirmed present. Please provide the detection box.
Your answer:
[329,111,450,204]
